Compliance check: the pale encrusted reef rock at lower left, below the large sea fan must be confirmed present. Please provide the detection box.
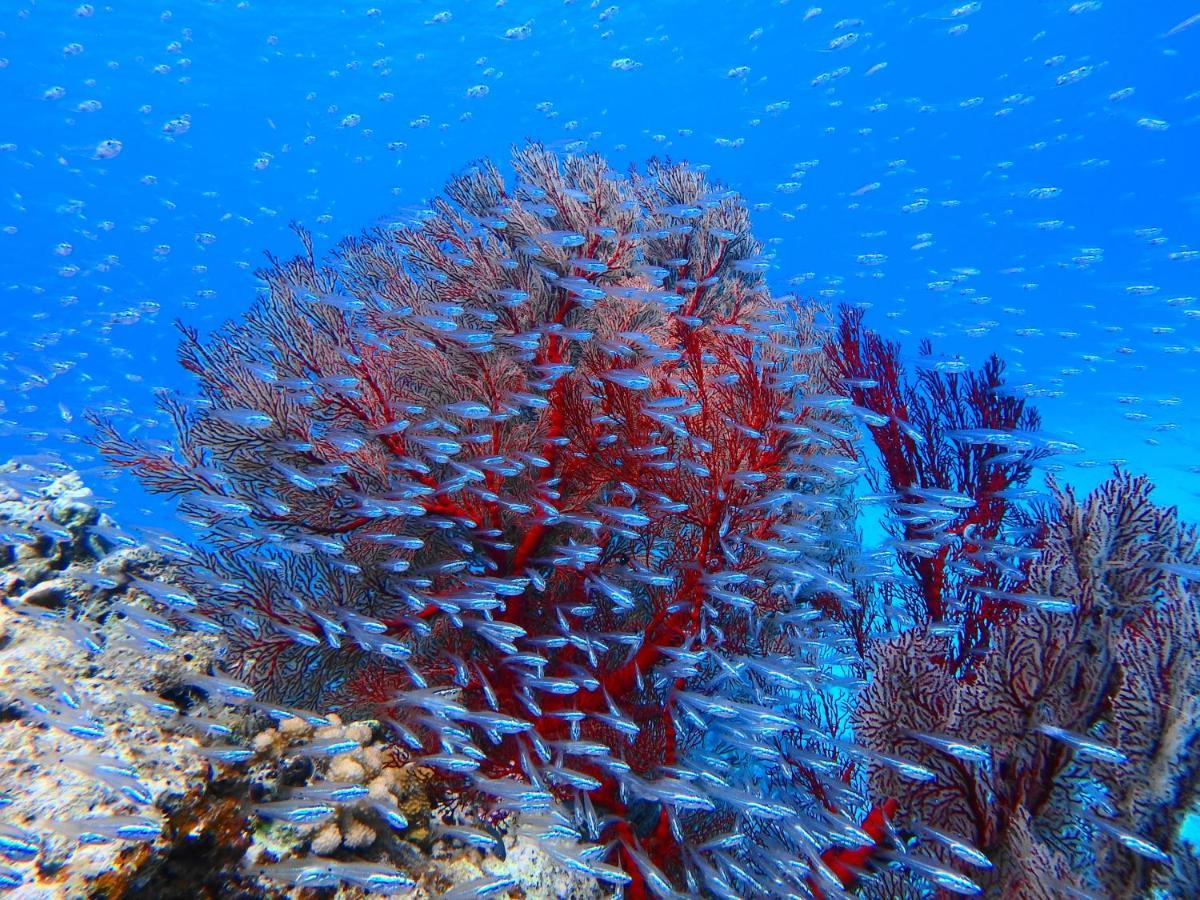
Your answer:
[0,461,606,900]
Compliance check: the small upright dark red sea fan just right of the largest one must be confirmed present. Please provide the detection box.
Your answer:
[827,308,1051,673]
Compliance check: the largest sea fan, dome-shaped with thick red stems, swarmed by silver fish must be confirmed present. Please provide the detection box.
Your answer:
[88,146,877,896]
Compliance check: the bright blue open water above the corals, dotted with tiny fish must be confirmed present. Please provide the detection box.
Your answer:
[0,0,1200,525]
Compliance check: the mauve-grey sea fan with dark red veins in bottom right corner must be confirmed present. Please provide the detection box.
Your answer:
[856,473,1200,898]
